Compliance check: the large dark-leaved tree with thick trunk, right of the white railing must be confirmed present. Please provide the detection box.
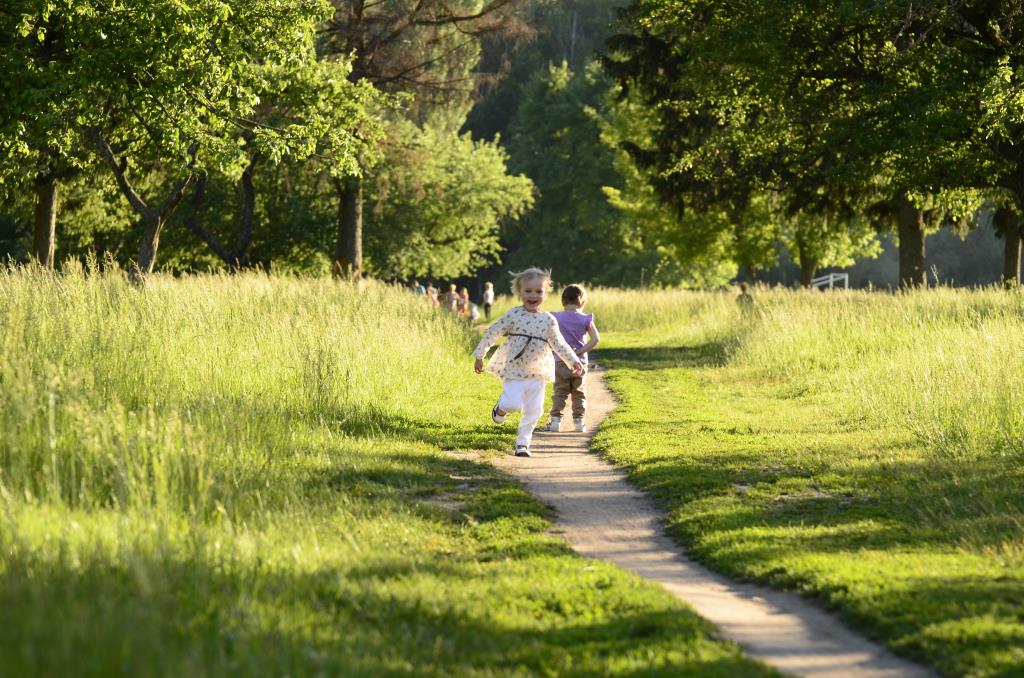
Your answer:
[606,0,965,285]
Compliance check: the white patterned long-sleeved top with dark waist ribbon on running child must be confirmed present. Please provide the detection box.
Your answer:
[473,306,581,381]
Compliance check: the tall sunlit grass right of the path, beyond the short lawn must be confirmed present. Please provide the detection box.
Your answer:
[590,288,1024,457]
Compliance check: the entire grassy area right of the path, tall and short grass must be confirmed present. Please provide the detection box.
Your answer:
[592,290,1024,676]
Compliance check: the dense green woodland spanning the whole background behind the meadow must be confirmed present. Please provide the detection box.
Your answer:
[0,0,1020,292]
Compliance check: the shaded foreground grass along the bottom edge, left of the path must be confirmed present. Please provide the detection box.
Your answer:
[0,554,770,676]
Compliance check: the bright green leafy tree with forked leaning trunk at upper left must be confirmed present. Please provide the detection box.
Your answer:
[0,0,368,279]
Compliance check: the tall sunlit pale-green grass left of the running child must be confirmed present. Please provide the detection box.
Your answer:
[0,268,467,514]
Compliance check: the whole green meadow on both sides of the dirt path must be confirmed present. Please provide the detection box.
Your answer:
[0,268,1024,676]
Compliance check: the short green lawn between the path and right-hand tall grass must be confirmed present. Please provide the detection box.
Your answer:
[595,337,1024,676]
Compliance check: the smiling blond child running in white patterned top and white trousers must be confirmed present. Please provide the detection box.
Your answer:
[473,268,583,457]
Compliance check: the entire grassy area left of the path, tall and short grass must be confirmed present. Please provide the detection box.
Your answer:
[0,270,770,676]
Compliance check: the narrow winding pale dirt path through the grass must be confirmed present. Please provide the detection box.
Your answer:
[495,371,933,678]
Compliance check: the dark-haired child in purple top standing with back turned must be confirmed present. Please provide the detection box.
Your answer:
[548,285,601,433]
